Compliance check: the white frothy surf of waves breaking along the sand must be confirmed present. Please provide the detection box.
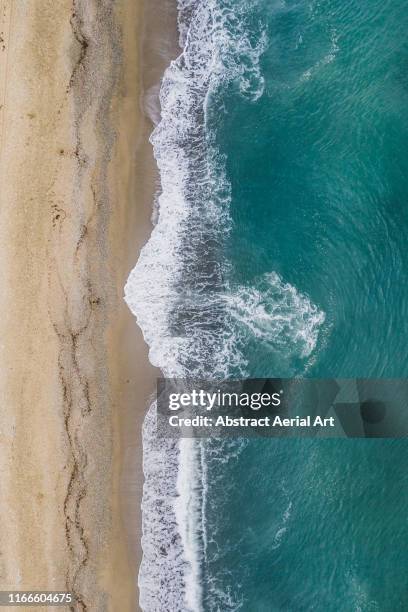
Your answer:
[125,0,322,612]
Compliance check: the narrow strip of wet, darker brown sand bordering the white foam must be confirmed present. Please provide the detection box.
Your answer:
[121,0,180,609]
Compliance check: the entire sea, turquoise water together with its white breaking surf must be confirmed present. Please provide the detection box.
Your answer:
[125,0,408,612]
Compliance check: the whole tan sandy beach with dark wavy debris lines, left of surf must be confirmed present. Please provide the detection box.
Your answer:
[0,0,162,611]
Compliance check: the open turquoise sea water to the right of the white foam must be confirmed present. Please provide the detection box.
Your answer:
[203,0,408,612]
